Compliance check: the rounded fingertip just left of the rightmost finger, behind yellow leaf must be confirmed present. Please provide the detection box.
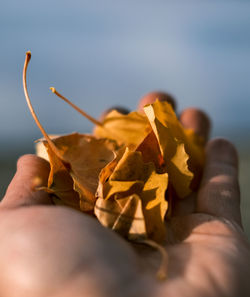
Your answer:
[180,108,211,142]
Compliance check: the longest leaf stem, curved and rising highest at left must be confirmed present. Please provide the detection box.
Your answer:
[23,51,62,158]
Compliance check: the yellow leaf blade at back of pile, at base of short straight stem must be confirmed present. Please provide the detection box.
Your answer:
[94,110,151,149]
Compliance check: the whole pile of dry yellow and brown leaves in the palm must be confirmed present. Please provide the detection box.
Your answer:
[23,52,204,244]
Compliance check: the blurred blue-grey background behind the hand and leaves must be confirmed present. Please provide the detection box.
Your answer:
[0,0,250,238]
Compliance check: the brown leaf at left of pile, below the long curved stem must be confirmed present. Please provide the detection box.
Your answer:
[40,133,115,211]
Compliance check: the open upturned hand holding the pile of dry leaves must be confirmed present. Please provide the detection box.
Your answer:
[0,100,250,297]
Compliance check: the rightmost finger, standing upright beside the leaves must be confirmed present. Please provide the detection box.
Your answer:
[196,139,241,225]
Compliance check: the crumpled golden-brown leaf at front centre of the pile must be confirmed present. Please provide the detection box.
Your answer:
[95,148,168,242]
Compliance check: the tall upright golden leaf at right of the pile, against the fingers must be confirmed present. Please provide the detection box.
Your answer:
[144,100,203,198]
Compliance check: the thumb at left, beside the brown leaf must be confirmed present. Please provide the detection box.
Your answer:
[1,155,51,208]
